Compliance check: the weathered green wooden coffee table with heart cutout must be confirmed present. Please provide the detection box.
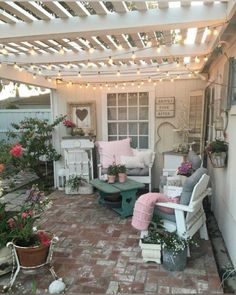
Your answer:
[90,179,145,218]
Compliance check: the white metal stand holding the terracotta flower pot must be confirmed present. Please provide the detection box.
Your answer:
[4,237,59,292]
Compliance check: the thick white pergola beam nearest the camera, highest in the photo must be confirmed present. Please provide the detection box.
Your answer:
[0,3,227,43]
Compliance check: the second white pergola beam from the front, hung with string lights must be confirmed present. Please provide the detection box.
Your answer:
[0,44,210,65]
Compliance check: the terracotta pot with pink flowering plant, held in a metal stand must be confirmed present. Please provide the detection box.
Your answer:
[6,185,55,267]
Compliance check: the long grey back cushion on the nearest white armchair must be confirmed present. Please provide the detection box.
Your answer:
[180,167,207,205]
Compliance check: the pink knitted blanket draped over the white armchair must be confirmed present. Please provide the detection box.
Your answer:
[131,193,180,230]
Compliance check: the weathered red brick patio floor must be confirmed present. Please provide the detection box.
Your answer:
[1,191,223,295]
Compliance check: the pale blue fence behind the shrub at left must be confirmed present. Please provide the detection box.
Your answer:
[0,109,51,140]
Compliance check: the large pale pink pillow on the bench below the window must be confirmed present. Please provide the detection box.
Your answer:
[96,138,133,168]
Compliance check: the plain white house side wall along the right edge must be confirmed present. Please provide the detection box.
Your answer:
[209,40,236,267]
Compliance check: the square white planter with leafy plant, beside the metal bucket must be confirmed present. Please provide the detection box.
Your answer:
[139,216,163,264]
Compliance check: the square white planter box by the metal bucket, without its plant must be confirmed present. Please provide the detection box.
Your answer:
[139,240,161,264]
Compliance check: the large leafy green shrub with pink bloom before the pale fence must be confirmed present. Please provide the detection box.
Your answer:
[8,116,65,178]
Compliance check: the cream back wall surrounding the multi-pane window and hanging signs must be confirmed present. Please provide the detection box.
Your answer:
[52,79,206,188]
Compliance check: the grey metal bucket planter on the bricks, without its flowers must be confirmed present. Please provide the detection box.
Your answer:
[162,247,187,271]
